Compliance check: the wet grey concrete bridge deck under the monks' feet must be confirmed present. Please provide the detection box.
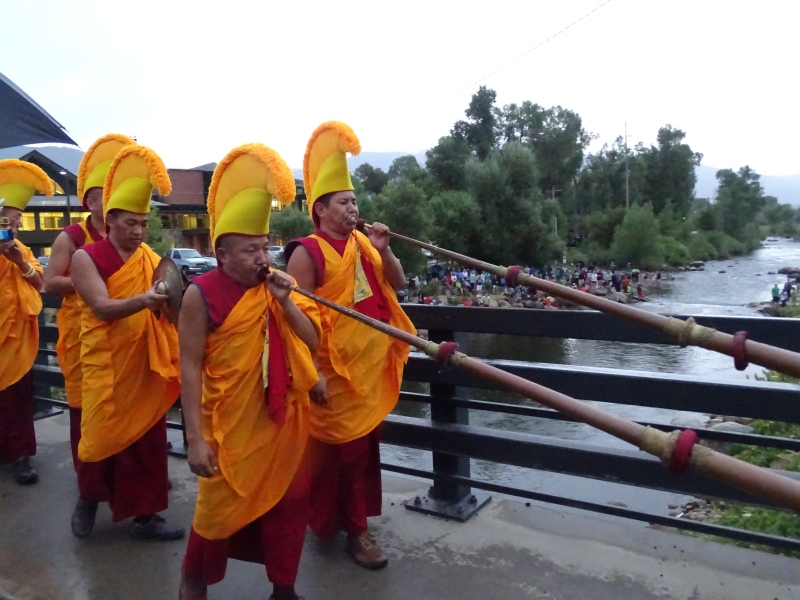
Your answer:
[0,415,800,600]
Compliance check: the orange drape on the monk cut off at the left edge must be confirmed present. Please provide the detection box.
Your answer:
[0,240,44,390]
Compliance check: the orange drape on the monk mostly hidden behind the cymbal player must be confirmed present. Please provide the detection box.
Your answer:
[56,221,94,408]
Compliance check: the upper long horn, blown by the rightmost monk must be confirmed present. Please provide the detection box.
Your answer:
[358,220,800,377]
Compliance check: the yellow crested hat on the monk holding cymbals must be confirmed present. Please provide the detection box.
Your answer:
[103,144,172,215]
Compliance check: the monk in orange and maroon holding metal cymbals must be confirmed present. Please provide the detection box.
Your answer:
[71,146,184,541]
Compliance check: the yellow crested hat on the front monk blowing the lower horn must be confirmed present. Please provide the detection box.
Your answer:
[208,144,295,247]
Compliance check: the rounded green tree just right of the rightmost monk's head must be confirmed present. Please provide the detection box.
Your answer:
[375,180,430,273]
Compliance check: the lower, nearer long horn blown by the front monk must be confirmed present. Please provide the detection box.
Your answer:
[278,273,800,513]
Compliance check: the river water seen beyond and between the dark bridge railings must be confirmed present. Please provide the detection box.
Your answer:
[384,238,800,514]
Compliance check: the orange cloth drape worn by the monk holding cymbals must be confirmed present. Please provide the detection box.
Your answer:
[78,244,180,462]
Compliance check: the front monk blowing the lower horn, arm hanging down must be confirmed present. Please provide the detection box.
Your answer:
[179,144,321,600]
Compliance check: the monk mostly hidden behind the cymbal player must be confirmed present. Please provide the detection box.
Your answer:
[44,133,136,537]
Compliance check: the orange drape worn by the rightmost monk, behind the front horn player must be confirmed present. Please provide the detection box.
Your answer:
[311,232,416,444]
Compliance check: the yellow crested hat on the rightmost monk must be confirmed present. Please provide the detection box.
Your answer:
[303,121,361,215]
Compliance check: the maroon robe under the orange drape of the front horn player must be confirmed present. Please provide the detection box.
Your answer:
[183,269,311,586]
